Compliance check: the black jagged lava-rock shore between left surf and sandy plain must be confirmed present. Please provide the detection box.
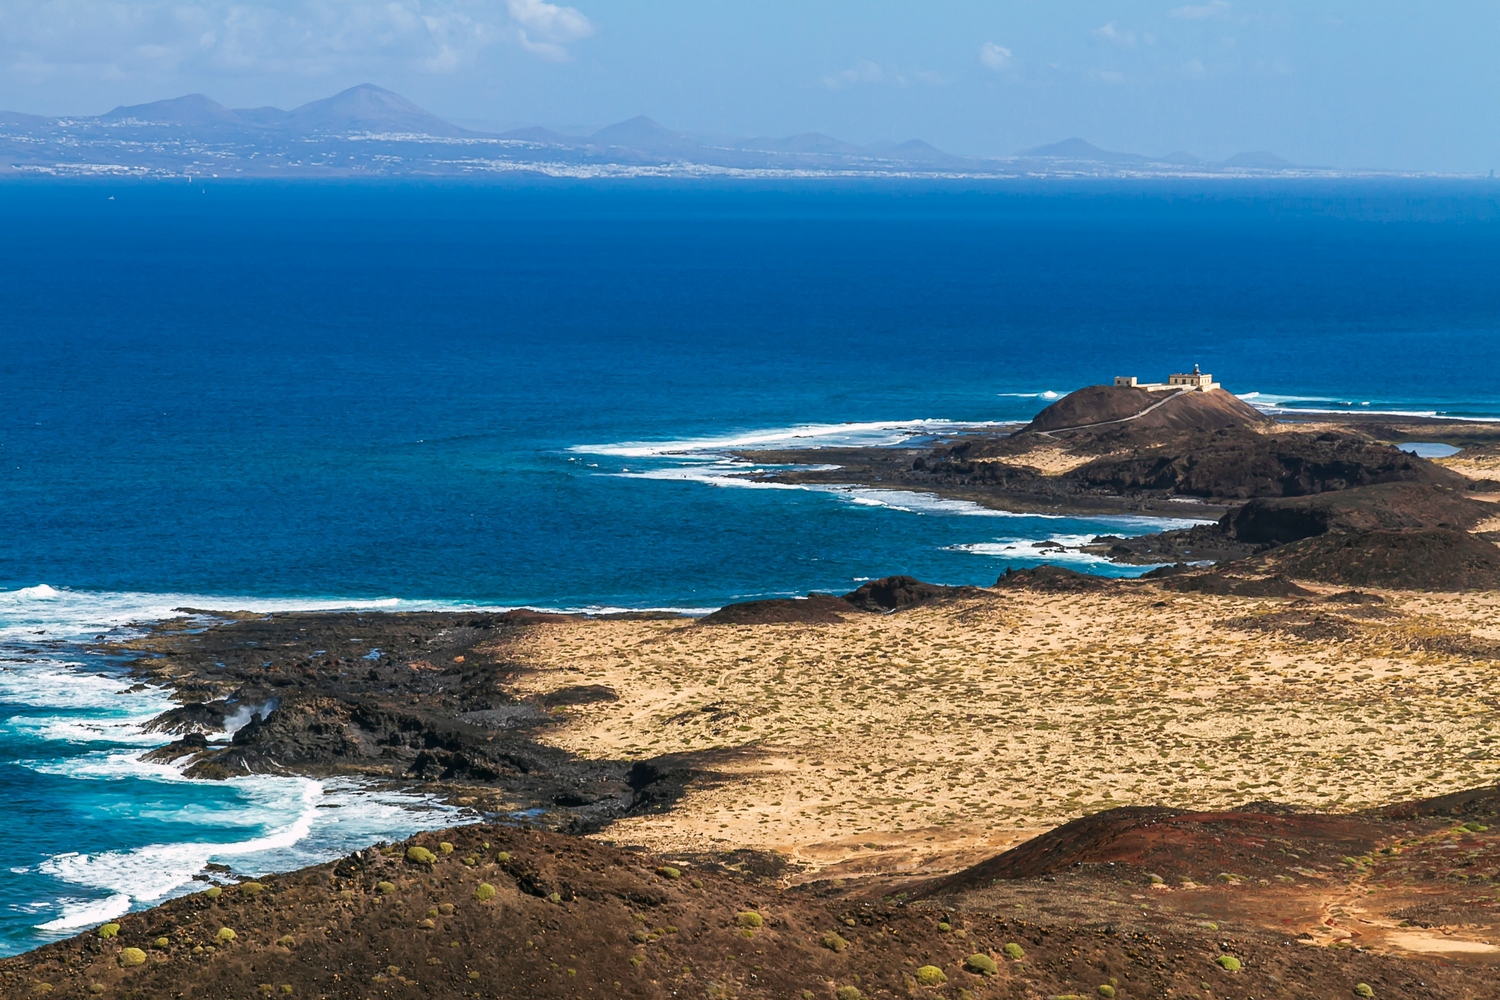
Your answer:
[108,612,707,834]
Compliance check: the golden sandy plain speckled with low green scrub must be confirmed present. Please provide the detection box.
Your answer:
[489,588,1500,871]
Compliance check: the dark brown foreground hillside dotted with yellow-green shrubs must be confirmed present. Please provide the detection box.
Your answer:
[0,809,1500,1000]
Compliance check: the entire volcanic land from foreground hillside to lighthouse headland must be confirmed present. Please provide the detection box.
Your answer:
[0,380,1500,1000]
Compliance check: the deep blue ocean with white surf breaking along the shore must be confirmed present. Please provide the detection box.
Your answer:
[0,181,1500,954]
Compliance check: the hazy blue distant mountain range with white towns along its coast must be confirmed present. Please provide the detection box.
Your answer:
[0,84,1334,178]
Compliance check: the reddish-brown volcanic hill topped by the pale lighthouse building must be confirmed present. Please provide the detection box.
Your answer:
[1019,385,1271,435]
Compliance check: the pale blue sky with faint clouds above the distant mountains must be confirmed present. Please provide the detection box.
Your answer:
[0,0,1500,172]
